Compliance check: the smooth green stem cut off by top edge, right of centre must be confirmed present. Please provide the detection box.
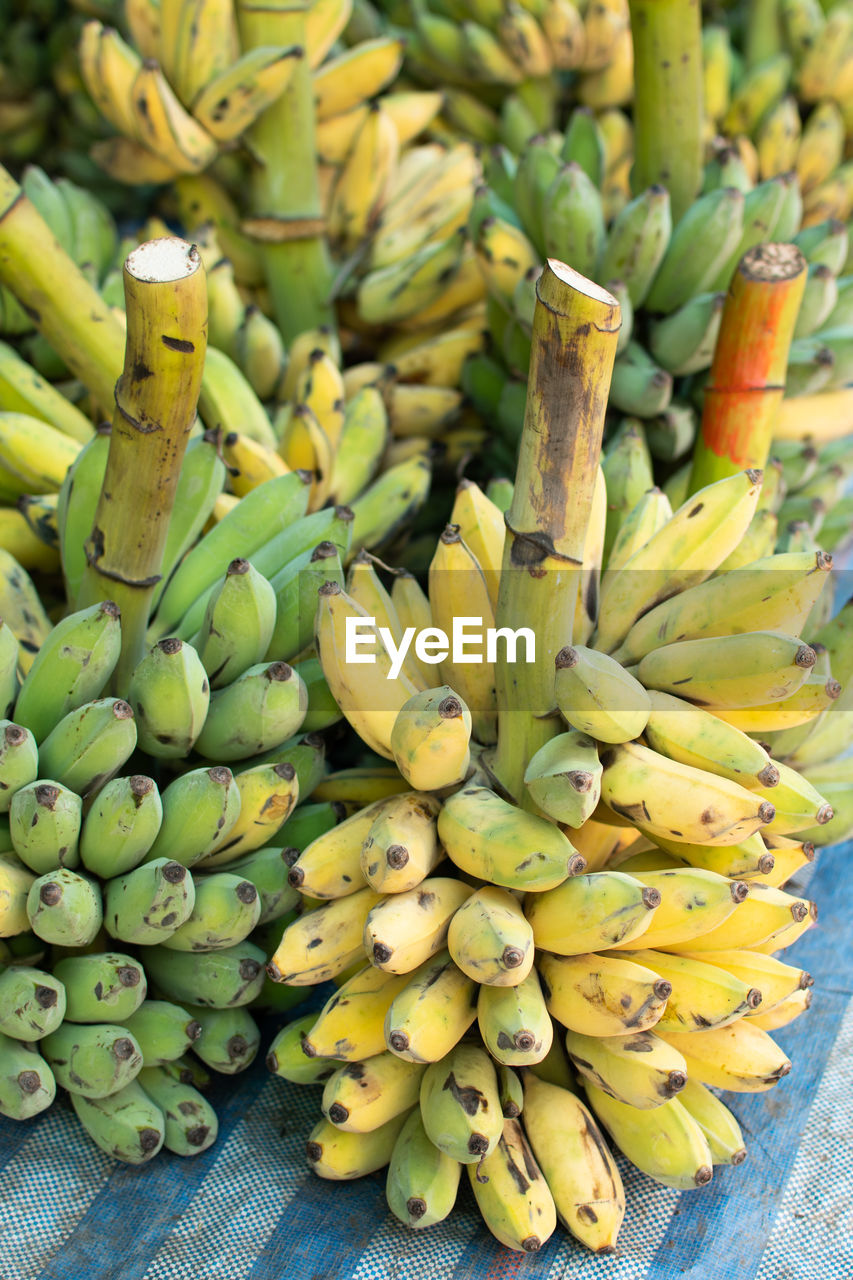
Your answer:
[629,0,704,223]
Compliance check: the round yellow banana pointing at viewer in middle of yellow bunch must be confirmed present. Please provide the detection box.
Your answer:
[445,882,533,987]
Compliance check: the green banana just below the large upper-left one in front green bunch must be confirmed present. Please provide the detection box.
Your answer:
[38,698,136,796]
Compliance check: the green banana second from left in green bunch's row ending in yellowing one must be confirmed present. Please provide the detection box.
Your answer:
[79,773,163,879]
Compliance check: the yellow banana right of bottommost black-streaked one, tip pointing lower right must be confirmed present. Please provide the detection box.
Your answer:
[587,1082,713,1190]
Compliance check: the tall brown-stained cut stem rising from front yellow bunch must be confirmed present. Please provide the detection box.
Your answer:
[489,260,621,801]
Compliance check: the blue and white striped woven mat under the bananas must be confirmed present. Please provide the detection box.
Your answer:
[0,845,853,1280]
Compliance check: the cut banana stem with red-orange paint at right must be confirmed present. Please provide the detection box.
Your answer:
[689,244,807,493]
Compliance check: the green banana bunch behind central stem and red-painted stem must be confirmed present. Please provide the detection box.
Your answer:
[462,109,853,467]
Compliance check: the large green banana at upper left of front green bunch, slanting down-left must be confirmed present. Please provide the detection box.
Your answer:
[15,600,120,742]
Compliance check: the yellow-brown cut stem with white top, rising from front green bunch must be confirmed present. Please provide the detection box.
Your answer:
[77,237,207,691]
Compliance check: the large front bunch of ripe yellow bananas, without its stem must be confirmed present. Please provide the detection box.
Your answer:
[258,468,829,1252]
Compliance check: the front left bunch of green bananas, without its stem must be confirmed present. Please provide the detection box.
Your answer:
[0,547,352,1165]
